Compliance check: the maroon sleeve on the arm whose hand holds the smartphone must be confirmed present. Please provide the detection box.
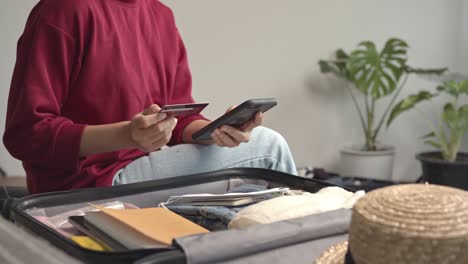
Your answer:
[168,31,207,146]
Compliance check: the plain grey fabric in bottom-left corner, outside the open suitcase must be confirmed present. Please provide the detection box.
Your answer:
[0,218,81,264]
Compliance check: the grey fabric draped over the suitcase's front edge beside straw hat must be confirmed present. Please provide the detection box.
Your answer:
[176,209,351,264]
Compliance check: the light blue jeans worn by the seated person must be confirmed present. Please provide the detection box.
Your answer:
[113,127,297,185]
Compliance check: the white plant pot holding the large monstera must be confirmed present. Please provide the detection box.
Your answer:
[339,146,395,180]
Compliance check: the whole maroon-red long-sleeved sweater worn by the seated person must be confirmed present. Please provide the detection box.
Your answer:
[3,0,203,193]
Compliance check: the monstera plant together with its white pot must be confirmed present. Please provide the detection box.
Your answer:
[319,38,446,180]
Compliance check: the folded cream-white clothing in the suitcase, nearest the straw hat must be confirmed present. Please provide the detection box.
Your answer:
[228,187,365,229]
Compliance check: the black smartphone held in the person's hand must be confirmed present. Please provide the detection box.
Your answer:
[192,98,277,140]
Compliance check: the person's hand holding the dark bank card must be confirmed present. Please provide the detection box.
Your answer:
[128,104,177,152]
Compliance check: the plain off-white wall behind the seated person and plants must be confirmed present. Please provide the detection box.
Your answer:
[0,0,466,179]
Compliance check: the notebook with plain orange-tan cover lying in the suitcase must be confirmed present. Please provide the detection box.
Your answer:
[85,207,209,249]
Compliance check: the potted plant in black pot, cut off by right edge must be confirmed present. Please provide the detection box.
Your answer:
[387,81,468,190]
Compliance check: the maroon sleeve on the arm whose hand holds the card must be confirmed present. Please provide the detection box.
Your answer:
[3,17,85,170]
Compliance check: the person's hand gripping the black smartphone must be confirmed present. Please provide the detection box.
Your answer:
[211,107,263,148]
